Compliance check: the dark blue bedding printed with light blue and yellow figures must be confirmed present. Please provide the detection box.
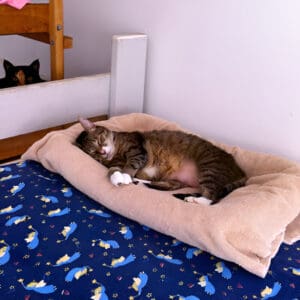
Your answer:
[0,161,300,300]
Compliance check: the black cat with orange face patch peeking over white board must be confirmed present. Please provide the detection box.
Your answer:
[0,59,44,88]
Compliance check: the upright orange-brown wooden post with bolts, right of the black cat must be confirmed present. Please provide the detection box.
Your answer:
[49,0,64,80]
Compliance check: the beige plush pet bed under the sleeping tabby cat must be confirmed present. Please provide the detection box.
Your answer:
[22,114,300,277]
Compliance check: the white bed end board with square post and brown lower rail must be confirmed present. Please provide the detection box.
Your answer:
[0,35,147,163]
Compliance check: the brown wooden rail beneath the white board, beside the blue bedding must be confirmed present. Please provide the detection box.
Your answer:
[0,115,107,163]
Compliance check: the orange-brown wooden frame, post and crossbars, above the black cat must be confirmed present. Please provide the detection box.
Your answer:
[0,0,73,80]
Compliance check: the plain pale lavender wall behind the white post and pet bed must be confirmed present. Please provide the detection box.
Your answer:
[0,0,300,161]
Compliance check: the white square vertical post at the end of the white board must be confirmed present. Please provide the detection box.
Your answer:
[109,34,147,116]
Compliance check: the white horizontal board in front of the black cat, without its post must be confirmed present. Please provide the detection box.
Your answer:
[0,74,110,139]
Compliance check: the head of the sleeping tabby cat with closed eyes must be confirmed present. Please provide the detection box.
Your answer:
[76,118,115,162]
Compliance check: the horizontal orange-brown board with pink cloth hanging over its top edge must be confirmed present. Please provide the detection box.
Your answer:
[0,3,49,35]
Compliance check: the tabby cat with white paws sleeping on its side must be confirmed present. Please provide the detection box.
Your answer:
[76,118,246,203]
